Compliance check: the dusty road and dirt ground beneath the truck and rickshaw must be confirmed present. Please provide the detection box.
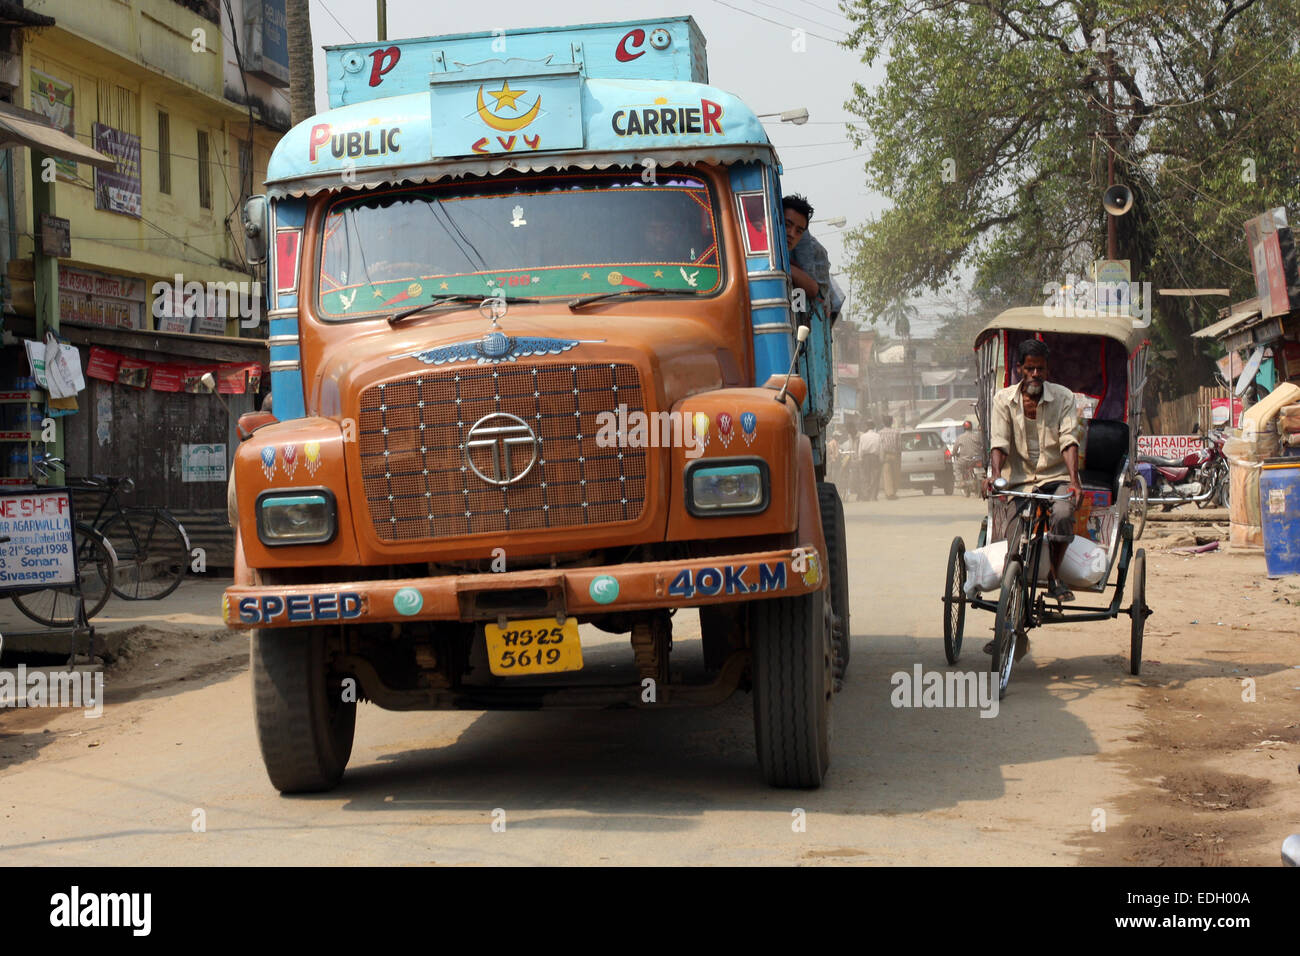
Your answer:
[0,494,1300,865]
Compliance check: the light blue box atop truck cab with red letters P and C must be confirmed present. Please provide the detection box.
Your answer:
[325,17,709,109]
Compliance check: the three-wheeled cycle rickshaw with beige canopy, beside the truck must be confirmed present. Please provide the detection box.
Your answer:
[944,307,1151,696]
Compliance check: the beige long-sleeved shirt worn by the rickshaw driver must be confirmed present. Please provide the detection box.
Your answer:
[989,380,1079,488]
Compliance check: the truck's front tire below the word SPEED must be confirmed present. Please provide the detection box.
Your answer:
[250,627,356,793]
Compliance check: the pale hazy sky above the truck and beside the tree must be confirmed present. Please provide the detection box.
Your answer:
[302,0,946,335]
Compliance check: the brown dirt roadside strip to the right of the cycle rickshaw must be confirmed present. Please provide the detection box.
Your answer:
[1080,522,1300,866]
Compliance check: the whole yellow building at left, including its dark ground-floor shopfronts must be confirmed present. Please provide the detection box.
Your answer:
[0,0,289,535]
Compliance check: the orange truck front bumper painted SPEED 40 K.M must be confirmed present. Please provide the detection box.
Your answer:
[221,545,826,628]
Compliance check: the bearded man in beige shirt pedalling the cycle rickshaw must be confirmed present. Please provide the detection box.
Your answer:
[984,338,1083,601]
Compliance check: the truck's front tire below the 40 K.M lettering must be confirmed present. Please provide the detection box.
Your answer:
[749,589,835,788]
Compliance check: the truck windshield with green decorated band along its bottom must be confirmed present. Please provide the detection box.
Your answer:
[319,170,723,320]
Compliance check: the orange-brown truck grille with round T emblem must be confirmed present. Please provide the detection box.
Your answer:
[358,364,646,541]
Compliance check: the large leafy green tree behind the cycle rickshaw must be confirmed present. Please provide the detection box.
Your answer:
[846,0,1300,390]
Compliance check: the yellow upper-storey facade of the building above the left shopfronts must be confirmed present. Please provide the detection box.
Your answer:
[14,0,287,336]
